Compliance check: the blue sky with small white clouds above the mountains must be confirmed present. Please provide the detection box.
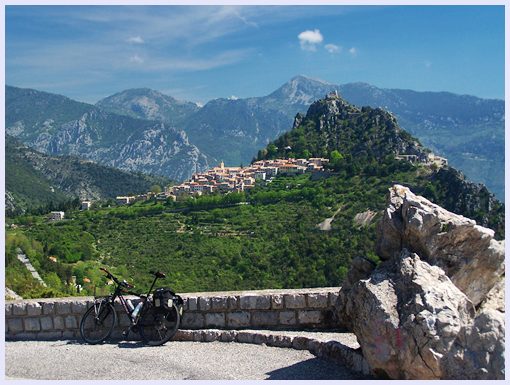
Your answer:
[5,5,505,103]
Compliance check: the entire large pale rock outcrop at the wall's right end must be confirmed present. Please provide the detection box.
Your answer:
[337,185,505,380]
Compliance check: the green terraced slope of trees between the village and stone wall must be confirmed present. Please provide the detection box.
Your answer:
[4,155,434,296]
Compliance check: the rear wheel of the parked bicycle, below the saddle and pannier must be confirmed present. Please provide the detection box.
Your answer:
[138,304,181,346]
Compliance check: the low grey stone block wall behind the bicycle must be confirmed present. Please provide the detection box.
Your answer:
[5,287,340,340]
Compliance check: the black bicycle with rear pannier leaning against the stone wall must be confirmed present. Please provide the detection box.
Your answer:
[80,268,184,346]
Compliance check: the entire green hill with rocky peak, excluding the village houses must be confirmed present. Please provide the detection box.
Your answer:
[6,97,504,296]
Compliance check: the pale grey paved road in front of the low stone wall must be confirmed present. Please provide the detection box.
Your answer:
[5,341,361,380]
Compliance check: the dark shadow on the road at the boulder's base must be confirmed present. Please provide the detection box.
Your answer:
[267,358,371,380]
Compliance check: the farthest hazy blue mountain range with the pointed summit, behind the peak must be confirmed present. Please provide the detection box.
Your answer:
[98,75,504,200]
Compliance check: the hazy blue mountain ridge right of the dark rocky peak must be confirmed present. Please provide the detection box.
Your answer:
[338,83,505,200]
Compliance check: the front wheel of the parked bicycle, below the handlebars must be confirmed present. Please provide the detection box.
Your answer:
[80,302,117,345]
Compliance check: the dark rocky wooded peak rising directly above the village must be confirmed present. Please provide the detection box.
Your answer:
[259,94,429,161]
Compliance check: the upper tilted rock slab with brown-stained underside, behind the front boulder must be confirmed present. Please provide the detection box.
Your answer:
[376,185,505,306]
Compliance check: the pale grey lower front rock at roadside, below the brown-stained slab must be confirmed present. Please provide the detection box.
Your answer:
[342,250,504,380]
